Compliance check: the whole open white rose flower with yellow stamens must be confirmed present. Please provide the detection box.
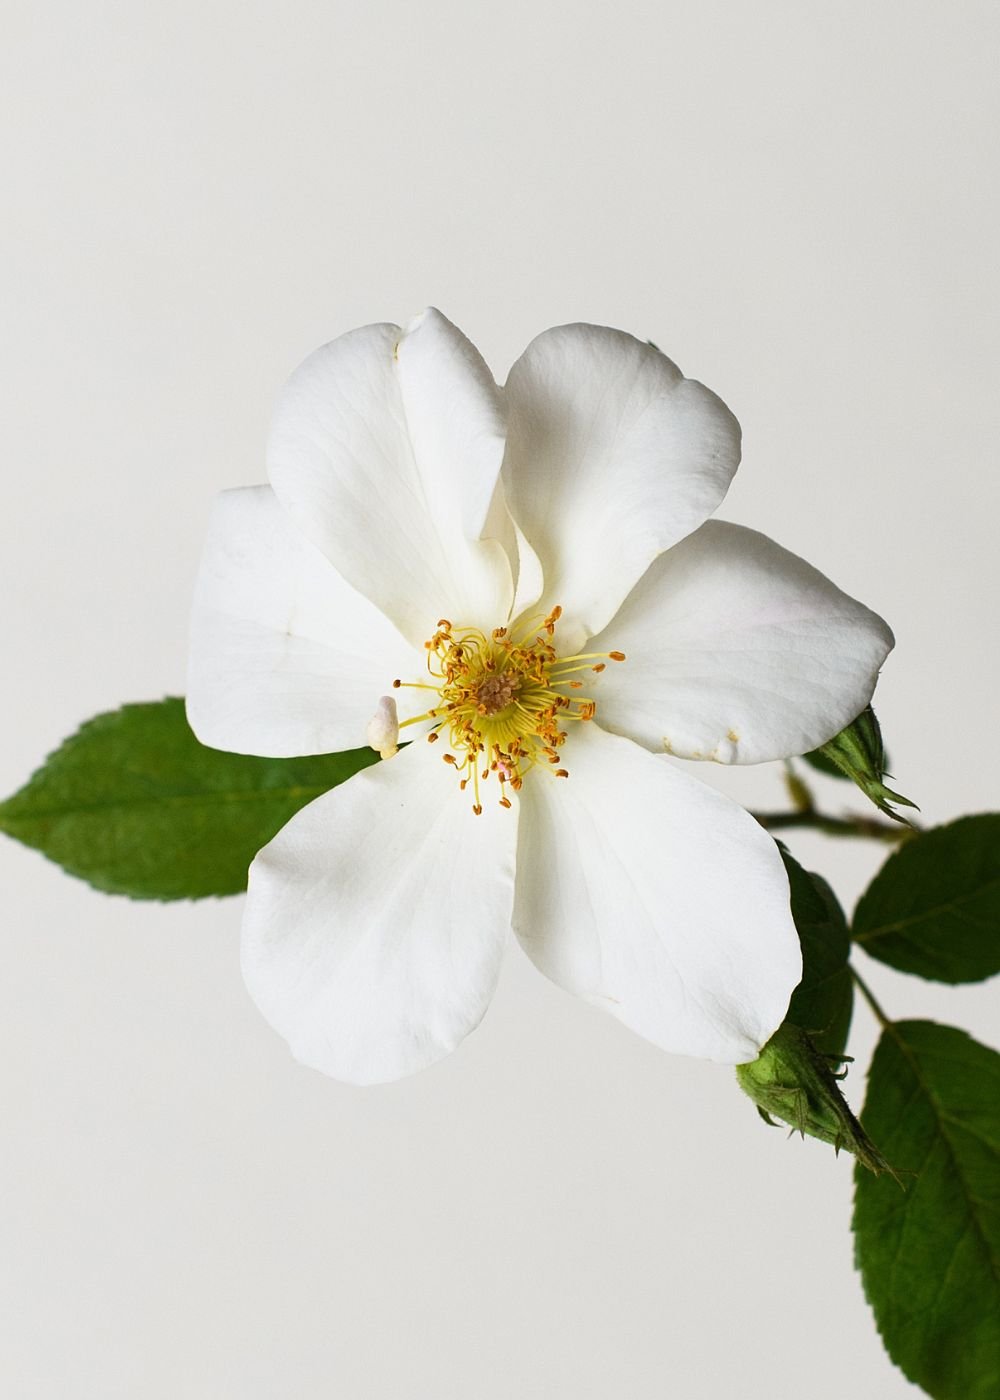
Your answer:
[188,311,892,1084]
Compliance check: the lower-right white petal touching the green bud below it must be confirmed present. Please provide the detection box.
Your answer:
[514,724,801,1064]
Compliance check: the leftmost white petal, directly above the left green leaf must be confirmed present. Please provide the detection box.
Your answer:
[188,486,414,757]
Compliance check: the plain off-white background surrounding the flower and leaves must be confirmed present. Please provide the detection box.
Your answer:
[0,0,1000,1400]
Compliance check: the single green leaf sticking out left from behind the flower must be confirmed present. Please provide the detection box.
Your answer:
[0,699,378,899]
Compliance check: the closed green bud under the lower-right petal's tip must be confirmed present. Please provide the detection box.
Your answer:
[737,1022,895,1176]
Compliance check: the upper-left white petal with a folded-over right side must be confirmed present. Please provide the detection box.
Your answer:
[268,311,513,647]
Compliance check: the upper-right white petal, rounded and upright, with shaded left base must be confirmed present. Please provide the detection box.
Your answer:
[504,326,739,645]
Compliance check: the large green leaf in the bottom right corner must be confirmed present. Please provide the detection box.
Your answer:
[854,1021,1000,1400]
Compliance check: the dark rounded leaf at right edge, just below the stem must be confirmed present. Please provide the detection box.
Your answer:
[854,812,1000,983]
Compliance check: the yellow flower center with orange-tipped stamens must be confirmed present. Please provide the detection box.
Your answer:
[392,608,625,816]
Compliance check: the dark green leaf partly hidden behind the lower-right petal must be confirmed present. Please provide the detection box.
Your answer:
[780,847,854,1056]
